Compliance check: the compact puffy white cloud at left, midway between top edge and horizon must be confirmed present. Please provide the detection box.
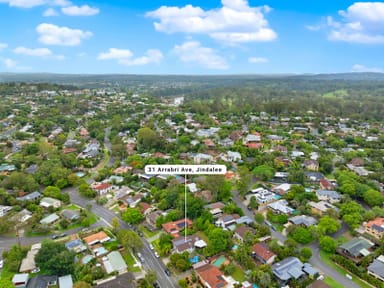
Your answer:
[36,23,93,46]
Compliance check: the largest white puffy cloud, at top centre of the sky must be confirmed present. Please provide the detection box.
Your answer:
[146,0,277,44]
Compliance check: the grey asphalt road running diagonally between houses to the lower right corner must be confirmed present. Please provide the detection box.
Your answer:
[232,191,360,288]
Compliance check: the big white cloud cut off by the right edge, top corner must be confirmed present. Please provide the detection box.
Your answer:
[327,2,384,44]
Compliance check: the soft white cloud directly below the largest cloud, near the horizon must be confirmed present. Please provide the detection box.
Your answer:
[172,41,229,70]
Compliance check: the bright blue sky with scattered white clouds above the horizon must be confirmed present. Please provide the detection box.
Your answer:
[0,0,384,74]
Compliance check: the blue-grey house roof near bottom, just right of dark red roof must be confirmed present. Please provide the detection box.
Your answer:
[272,257,304,281]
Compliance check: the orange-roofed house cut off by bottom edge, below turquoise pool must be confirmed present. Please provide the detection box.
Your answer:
[194,262,228,288]
